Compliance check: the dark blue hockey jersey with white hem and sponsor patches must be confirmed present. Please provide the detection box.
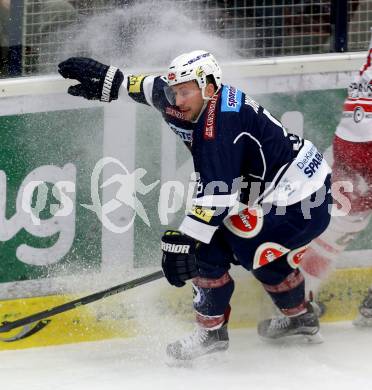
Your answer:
[122,75,330,243]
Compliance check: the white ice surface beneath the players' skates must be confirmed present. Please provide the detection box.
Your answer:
[0,322,372,390]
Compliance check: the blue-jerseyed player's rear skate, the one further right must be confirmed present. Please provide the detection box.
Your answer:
[257,304,323,344]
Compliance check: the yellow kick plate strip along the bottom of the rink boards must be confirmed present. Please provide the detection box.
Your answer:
[0,268,372,350]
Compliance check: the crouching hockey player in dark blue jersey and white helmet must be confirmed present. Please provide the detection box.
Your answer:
[59,50,332,359]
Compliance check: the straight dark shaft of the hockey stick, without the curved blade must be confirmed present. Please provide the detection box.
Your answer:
[0,271,164,333]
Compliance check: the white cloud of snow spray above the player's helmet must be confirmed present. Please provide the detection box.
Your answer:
[61,1,237,69]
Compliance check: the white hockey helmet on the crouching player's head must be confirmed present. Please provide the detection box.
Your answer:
[166,50,222,100]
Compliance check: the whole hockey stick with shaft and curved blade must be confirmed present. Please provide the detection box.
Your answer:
[0,271,164,342]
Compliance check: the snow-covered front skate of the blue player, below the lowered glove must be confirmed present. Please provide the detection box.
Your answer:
[167,324,229,360]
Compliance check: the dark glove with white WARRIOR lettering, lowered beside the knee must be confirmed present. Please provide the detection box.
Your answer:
[161,230,200,287]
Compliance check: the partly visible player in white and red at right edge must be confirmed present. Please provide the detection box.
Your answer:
[302,40,372,326]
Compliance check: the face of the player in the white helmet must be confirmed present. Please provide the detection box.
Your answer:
[171,81,204,121]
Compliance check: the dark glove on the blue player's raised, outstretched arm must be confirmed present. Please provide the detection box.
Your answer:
[58,57,124,102]
